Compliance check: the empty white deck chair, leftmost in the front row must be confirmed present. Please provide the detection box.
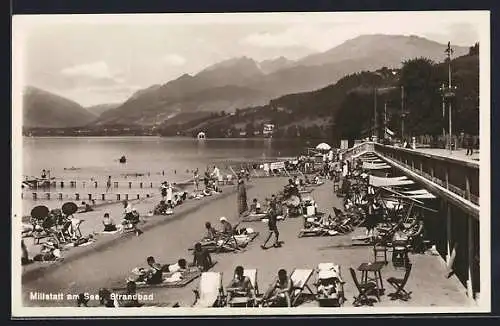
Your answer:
[192,272,226,308]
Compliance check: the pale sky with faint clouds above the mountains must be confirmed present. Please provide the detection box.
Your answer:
[13,11,489,106]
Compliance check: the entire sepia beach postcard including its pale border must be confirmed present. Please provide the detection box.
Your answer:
[11,11,491,317]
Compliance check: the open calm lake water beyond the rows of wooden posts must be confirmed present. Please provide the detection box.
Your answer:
[23,137,306,179]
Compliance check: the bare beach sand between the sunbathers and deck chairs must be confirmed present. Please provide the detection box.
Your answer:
[22,178,471,307]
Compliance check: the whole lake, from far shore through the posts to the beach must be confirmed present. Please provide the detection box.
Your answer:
[21,137,307,214]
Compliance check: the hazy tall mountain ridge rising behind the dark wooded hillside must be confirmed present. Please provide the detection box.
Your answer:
[22,35,468,126]
